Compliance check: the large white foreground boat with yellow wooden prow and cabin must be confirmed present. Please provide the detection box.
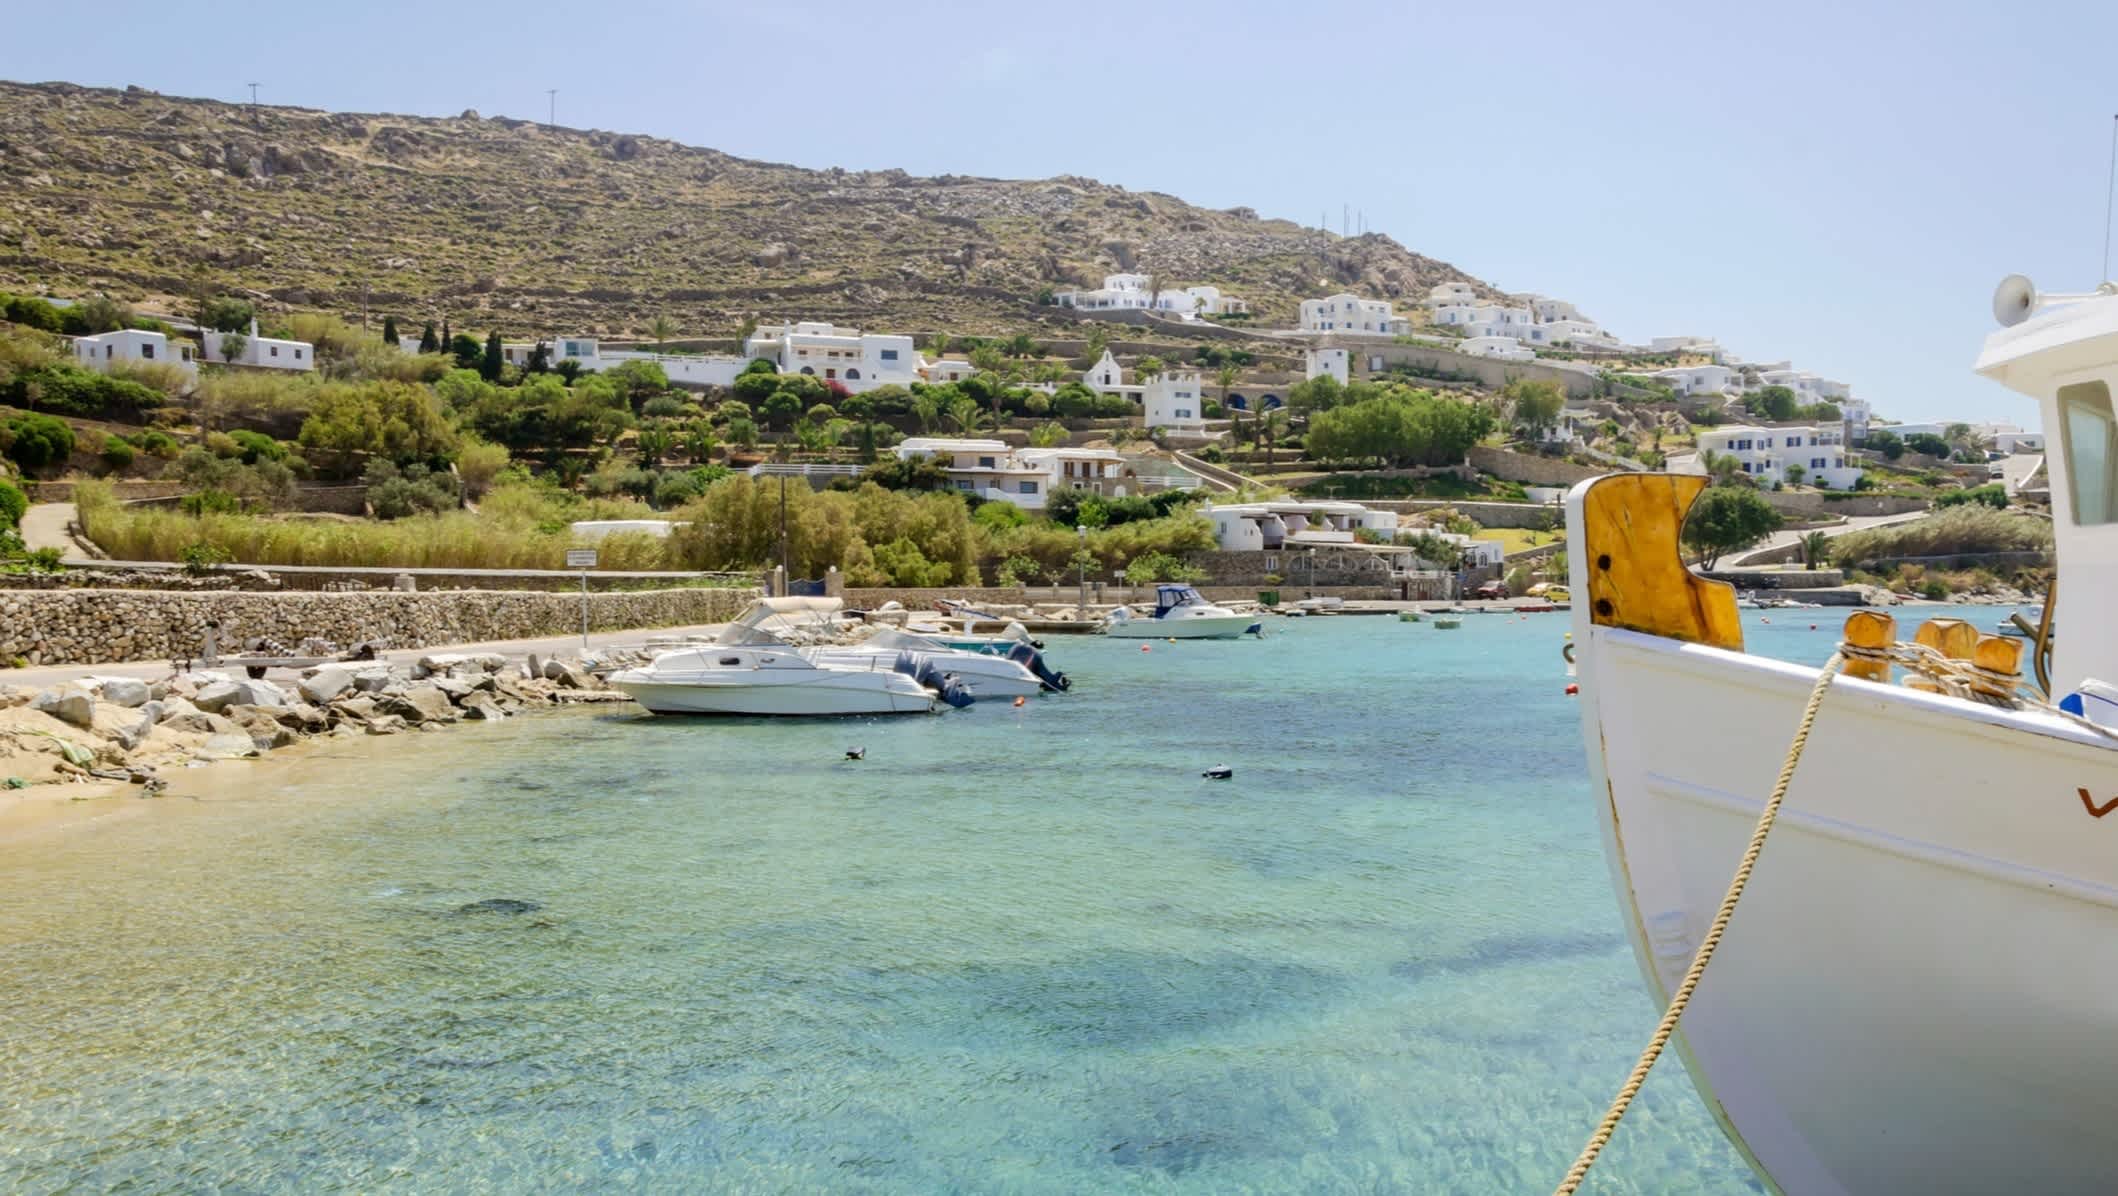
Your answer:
[1567,279,2118,1194]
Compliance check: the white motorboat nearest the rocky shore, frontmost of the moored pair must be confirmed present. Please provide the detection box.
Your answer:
[610,646,945,715]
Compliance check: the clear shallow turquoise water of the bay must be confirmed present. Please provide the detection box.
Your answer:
[0,612,1889,1192]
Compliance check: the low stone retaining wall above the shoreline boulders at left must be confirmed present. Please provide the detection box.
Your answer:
[0,588,758,665]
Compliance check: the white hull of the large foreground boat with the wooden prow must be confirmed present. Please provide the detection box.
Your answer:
[1574,626,2118,1194]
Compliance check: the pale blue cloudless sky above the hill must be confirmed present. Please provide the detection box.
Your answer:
[0,0,2118,421]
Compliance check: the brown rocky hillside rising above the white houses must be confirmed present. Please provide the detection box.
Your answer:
[0,83,1487,337]
